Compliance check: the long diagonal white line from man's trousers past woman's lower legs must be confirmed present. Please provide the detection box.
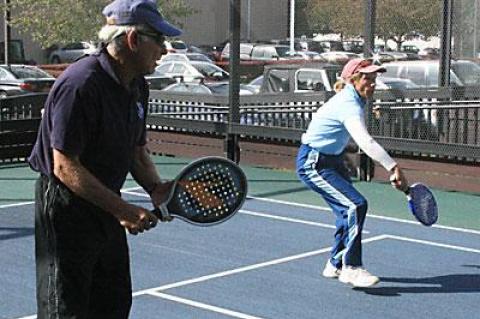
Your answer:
[133,235,386,296]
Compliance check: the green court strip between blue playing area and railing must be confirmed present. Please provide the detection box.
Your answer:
[0,156,480,230]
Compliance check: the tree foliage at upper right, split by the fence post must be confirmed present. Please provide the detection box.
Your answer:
[306,0,441,44]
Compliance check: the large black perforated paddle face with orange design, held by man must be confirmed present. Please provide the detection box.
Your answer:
[167,157,247,224]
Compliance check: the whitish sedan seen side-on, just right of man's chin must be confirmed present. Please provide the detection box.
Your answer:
[154,61,230,82]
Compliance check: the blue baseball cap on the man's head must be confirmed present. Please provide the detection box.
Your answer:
[102,0,182,37]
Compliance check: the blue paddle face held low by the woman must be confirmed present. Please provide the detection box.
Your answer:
[409,184,438,226]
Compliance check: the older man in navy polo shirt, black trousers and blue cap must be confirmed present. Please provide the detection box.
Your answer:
[29,0,181,319]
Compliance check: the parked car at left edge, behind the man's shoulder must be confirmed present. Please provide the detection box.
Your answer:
[0,64,55,98]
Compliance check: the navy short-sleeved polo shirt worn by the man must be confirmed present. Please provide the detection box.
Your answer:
[29,50,148,192]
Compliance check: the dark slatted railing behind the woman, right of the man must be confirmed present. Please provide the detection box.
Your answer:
[148,89,480,162]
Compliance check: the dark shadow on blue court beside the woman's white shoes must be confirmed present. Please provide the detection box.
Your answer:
[358,274,480,297]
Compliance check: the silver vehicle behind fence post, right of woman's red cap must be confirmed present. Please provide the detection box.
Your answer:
[379,60,480,88]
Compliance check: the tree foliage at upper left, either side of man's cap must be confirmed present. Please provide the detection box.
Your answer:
[3,0,194,48]
